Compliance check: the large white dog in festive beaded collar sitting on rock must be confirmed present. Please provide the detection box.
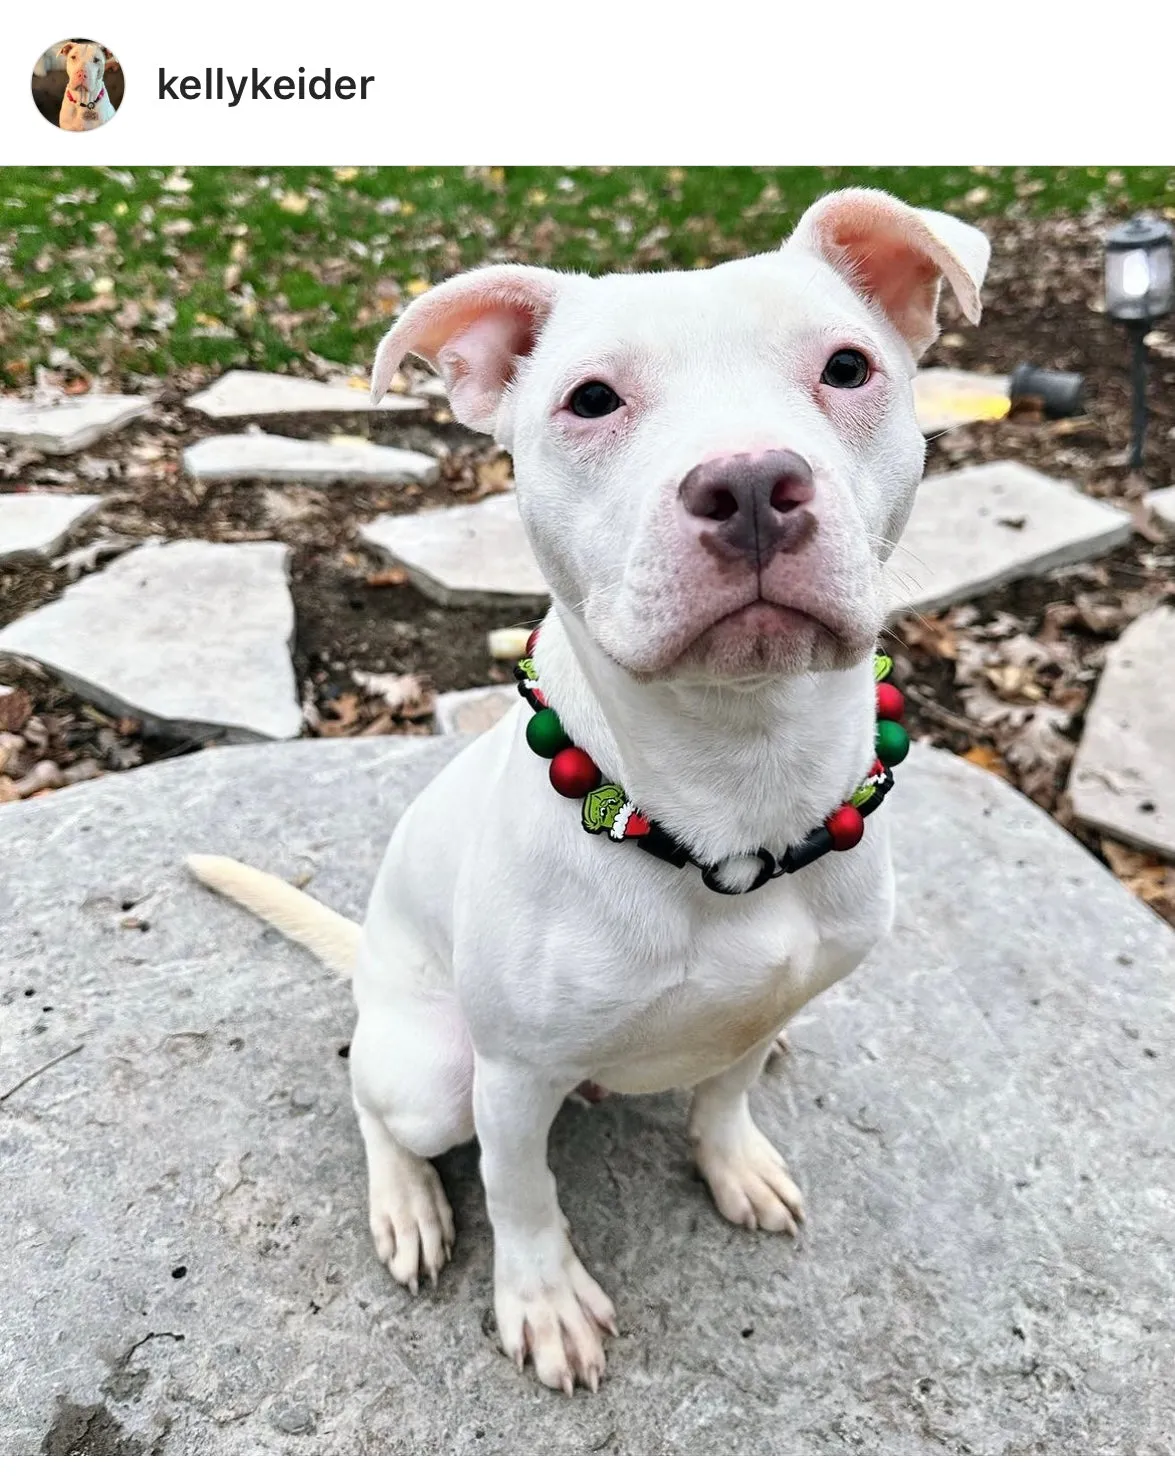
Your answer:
[190,190,988,1393]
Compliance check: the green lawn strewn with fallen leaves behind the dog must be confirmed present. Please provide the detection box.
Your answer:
[0,167,1175,385]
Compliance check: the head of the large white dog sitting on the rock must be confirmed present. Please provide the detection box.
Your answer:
[372,190,988,680]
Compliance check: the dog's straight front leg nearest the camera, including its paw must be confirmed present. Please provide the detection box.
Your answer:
[474,1057,616,1393]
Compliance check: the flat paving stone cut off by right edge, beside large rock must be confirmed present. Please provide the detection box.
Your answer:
[1069,605,1175,856]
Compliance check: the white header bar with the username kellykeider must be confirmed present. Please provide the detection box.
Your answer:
[0,0,1175,165]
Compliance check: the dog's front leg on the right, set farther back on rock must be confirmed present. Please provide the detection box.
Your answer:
[689,1036,803,1235]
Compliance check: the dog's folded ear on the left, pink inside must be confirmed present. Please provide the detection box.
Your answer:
[372,266,562,432]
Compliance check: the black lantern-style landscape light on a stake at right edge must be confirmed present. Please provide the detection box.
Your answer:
[1106,215,1175,466]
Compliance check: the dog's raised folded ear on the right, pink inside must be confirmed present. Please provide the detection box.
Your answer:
[785,189,990,359]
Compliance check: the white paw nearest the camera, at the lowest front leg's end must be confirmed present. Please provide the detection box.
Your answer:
[495,1240,616,1393]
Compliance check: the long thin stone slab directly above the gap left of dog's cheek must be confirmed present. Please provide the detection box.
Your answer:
[183,432,440,487]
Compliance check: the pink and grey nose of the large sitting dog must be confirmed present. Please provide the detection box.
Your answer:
[678,452,816,564]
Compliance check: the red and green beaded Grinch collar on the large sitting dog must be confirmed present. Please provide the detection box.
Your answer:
[514,627,909,896]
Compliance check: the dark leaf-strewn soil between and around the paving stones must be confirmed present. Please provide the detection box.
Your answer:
[0,220,1175,921]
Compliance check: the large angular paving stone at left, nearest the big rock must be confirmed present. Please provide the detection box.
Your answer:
[0,539,301,741]
